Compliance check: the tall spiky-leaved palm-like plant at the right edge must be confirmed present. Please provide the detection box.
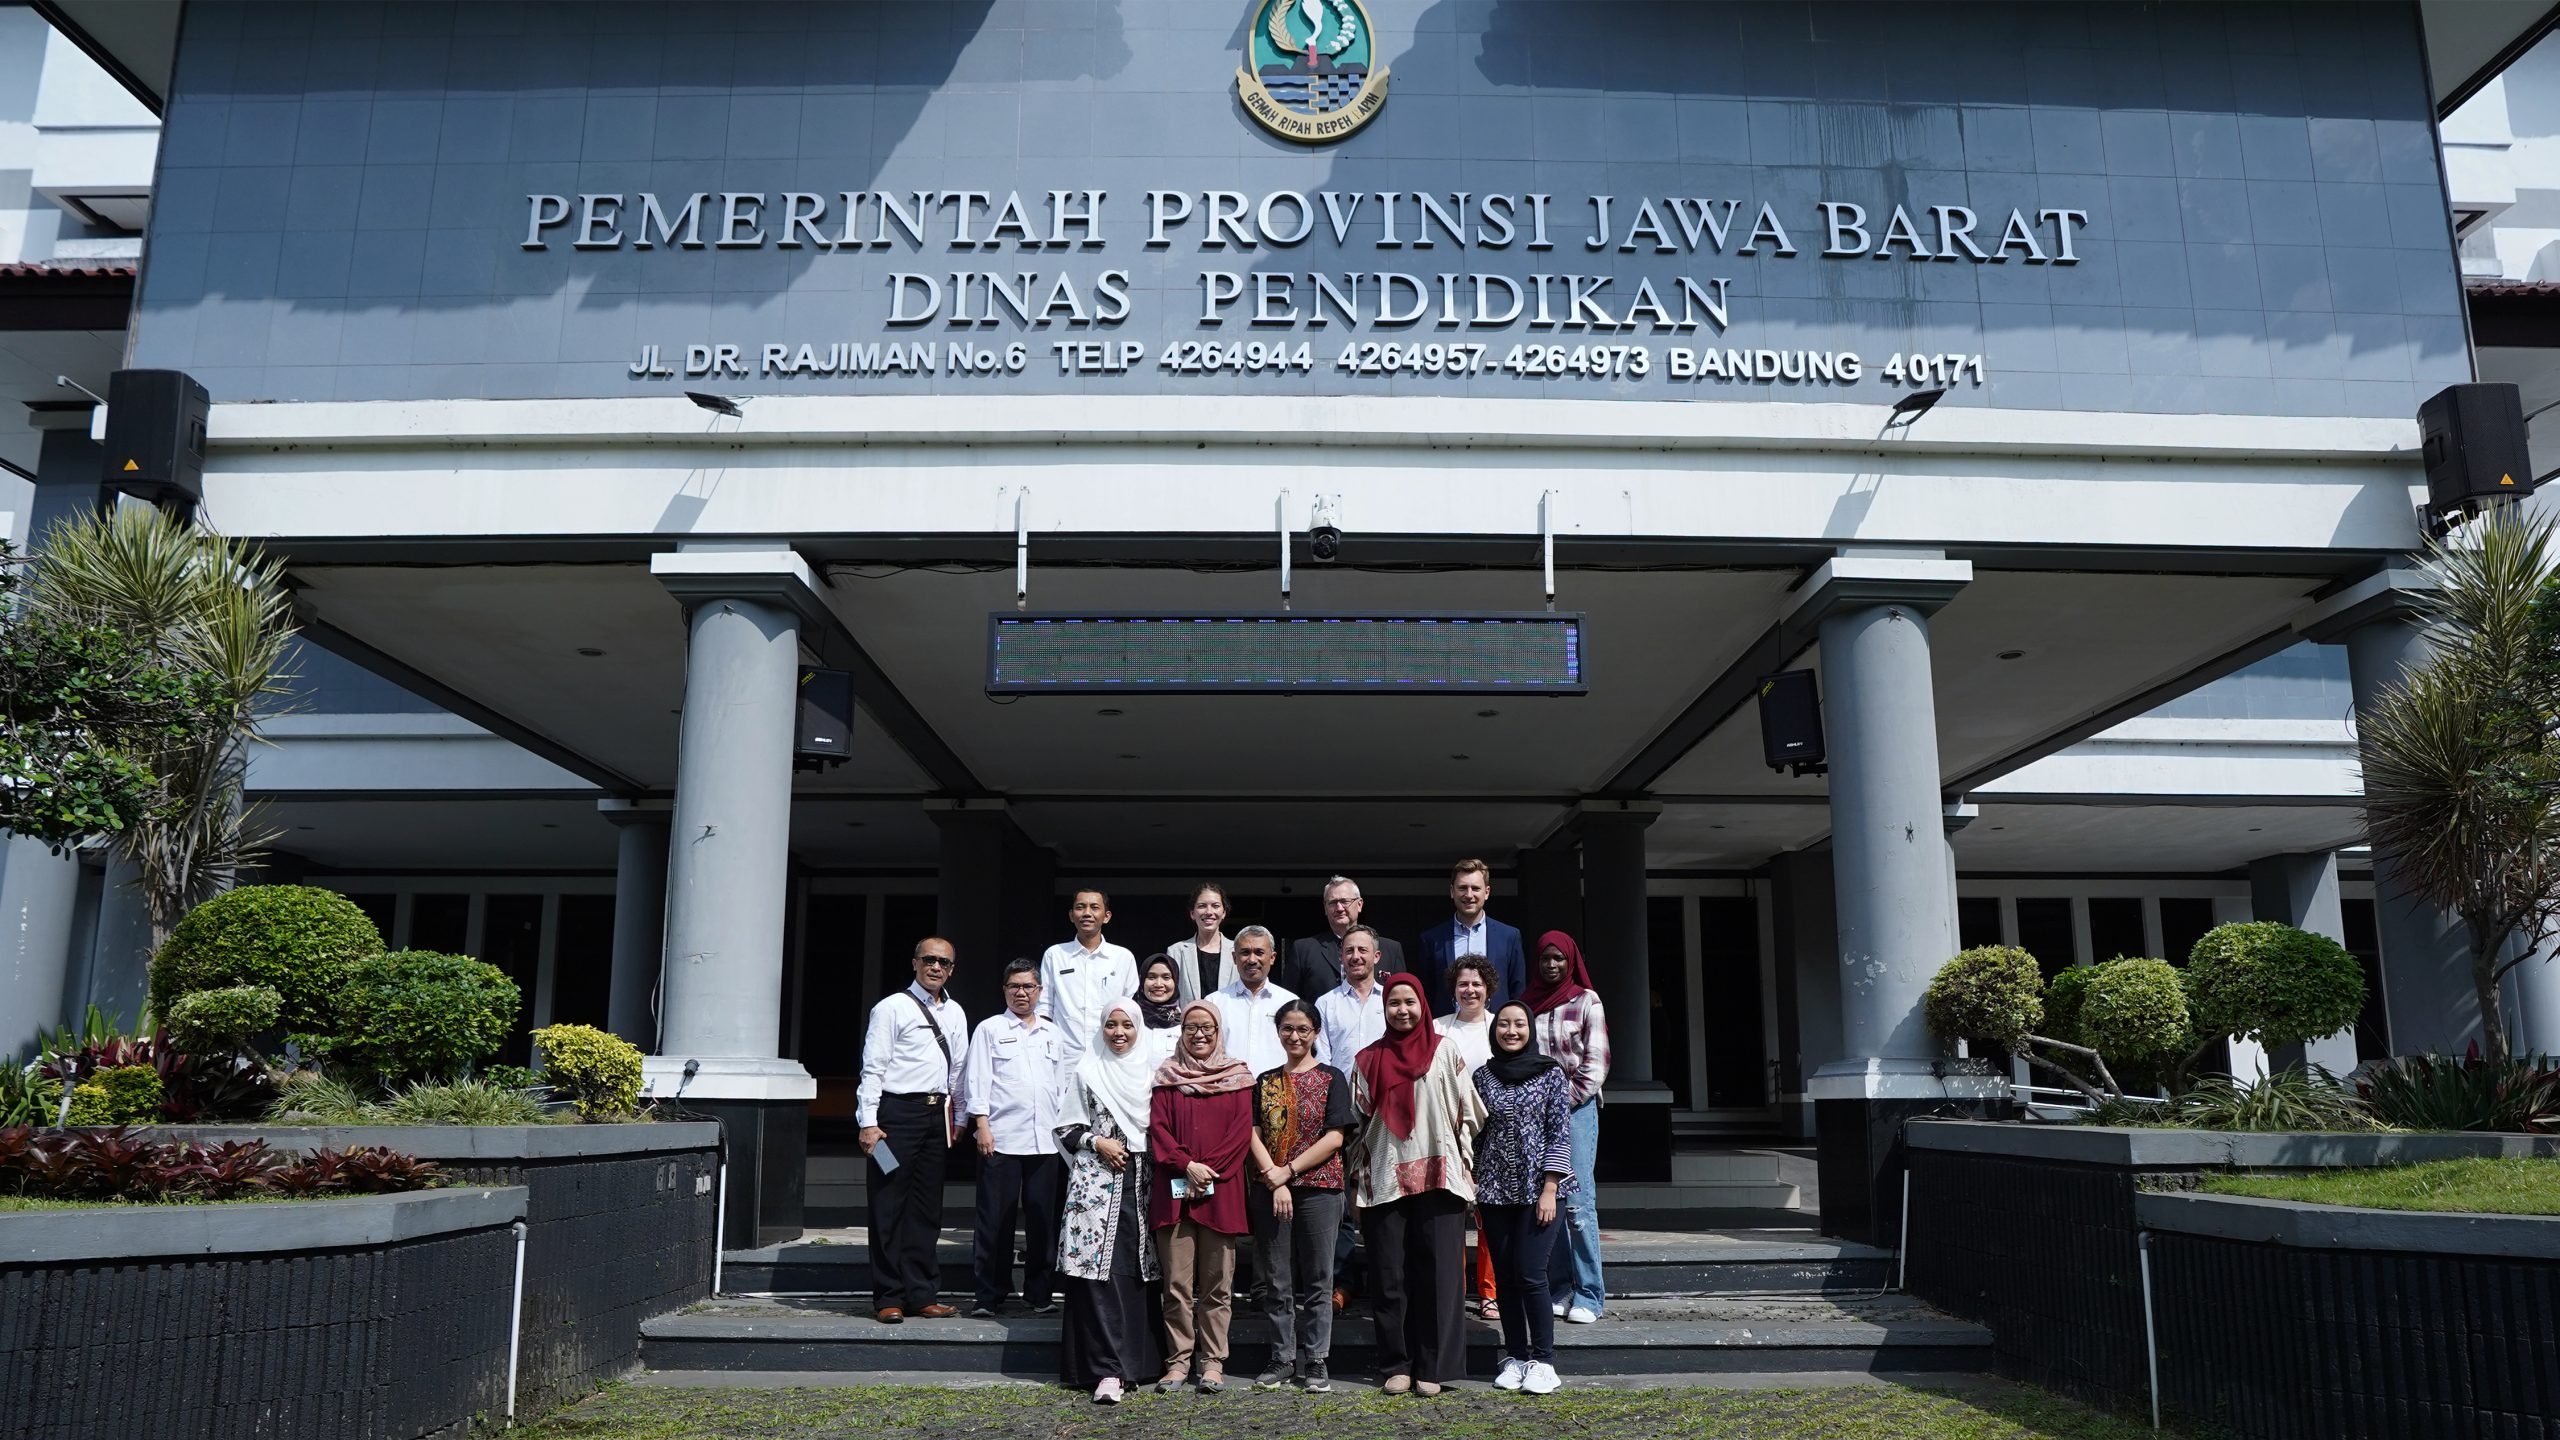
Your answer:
[2358,507,2560,1058]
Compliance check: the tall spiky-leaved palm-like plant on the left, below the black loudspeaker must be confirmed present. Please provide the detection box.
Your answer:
[28,505,294,951]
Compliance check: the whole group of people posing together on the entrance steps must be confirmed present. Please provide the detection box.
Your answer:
[858,861,1608,1404]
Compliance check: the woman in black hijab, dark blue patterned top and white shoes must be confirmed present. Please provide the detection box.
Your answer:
[1475,999,1574,1394]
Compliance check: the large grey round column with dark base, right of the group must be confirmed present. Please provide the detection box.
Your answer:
[1787,553,2004,1243]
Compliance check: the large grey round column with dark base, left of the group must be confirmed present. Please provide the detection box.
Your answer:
[643,543,835,1245]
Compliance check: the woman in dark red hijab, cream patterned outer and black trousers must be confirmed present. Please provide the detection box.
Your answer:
[1349,974,1485,1394]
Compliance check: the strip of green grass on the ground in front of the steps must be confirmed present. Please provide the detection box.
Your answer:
[517,1379,2153,1440]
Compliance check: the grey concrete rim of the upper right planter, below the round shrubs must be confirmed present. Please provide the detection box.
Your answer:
[1905,1120,2560,1171]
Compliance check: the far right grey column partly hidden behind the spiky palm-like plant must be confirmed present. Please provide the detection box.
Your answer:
[2345,610,2481,1056]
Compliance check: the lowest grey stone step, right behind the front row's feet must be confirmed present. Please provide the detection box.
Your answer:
[640,1281,1992,1379]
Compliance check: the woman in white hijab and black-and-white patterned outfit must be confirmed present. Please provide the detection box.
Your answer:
[1057,999,1162,1404]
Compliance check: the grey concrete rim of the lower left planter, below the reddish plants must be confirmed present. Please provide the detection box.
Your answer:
[0,1186,525,1266]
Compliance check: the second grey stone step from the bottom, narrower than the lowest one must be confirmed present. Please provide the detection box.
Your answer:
[722,1214,1894,1307]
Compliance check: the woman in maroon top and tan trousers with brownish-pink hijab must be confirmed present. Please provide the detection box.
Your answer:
[1147,999,1254,1394]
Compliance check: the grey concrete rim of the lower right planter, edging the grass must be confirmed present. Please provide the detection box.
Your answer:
[2132,1194,2560,1261]
